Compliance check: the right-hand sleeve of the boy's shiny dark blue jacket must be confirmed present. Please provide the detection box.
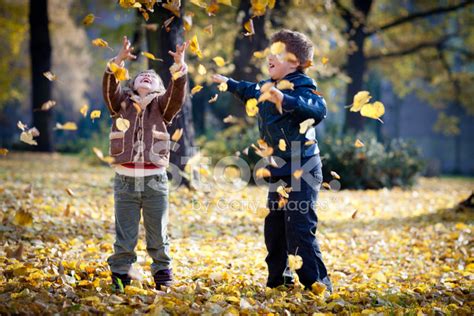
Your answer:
[282,88,327,125]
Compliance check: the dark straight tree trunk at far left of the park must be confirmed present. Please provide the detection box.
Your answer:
[29,0,54,152]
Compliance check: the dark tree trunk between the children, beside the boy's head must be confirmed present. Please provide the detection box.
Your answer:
[230,0,268,117]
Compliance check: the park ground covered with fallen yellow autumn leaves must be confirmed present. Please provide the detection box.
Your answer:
[0,153,474,315]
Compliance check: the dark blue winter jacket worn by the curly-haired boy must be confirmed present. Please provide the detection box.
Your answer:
[227,71,327,167]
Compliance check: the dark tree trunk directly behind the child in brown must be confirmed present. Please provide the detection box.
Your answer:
[146,1,194,175]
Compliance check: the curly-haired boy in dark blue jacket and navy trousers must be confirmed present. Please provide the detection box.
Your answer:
[212,30,332,292]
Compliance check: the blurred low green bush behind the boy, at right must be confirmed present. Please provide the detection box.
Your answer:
[320,132,424,189]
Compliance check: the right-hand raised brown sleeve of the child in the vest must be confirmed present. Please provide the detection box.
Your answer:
[159,64,188,124]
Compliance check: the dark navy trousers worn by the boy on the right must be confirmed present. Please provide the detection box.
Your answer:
[264,157,332,292]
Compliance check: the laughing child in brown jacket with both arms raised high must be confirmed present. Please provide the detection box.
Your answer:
[103,37,188,291]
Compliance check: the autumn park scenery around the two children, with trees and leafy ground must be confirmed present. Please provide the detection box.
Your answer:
[0,0,474,314]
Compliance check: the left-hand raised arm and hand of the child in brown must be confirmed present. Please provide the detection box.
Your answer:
[102,36,137,116]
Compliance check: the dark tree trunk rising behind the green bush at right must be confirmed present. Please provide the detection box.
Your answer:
[344,0,372,133]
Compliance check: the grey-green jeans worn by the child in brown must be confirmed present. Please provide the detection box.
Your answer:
[107,172,171,274]
